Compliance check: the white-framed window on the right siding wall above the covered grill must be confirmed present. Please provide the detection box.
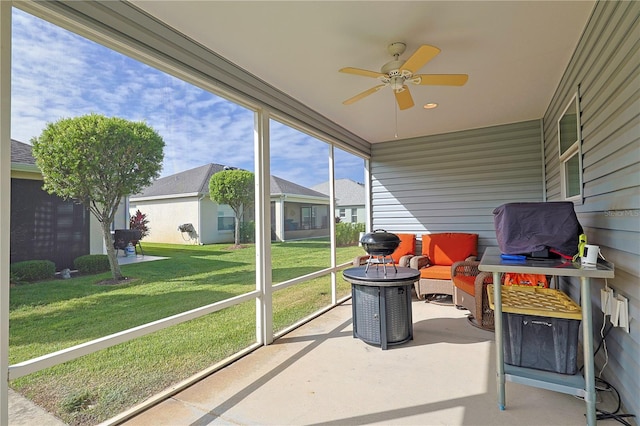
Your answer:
[558,93,582,201]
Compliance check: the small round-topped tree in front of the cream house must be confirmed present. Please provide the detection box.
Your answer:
[209,169,254,246]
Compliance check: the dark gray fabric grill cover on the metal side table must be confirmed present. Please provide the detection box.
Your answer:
[493,201,582,256]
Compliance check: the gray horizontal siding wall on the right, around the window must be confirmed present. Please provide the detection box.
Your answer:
[544,1,640,416]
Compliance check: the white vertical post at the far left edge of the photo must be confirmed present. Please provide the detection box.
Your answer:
[0,1,12,425]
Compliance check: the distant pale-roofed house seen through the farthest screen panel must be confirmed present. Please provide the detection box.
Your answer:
[311,179,367,223]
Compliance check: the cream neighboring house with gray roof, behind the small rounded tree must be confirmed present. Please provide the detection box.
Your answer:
[129,164,329,244]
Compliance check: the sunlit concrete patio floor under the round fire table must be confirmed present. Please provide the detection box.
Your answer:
[125,299,613,426]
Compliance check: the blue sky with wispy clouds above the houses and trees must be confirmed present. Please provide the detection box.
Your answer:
[11,8,363,187]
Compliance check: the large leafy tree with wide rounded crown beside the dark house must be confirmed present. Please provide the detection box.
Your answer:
[31,114,164,280]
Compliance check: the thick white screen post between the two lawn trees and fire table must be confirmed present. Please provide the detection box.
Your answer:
[254,109,273,345]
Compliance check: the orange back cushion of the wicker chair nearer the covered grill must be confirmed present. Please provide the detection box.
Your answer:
[422,232,478,266]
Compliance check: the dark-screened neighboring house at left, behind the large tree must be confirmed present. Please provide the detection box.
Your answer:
[10,140,94,270]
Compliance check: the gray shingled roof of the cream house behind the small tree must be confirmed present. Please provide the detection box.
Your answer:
[131,163,327,199]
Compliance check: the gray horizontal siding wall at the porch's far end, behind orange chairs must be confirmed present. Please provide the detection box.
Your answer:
[371,120,543,253]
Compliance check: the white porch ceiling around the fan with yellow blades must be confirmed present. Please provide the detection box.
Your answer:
[132,0,595,143]
